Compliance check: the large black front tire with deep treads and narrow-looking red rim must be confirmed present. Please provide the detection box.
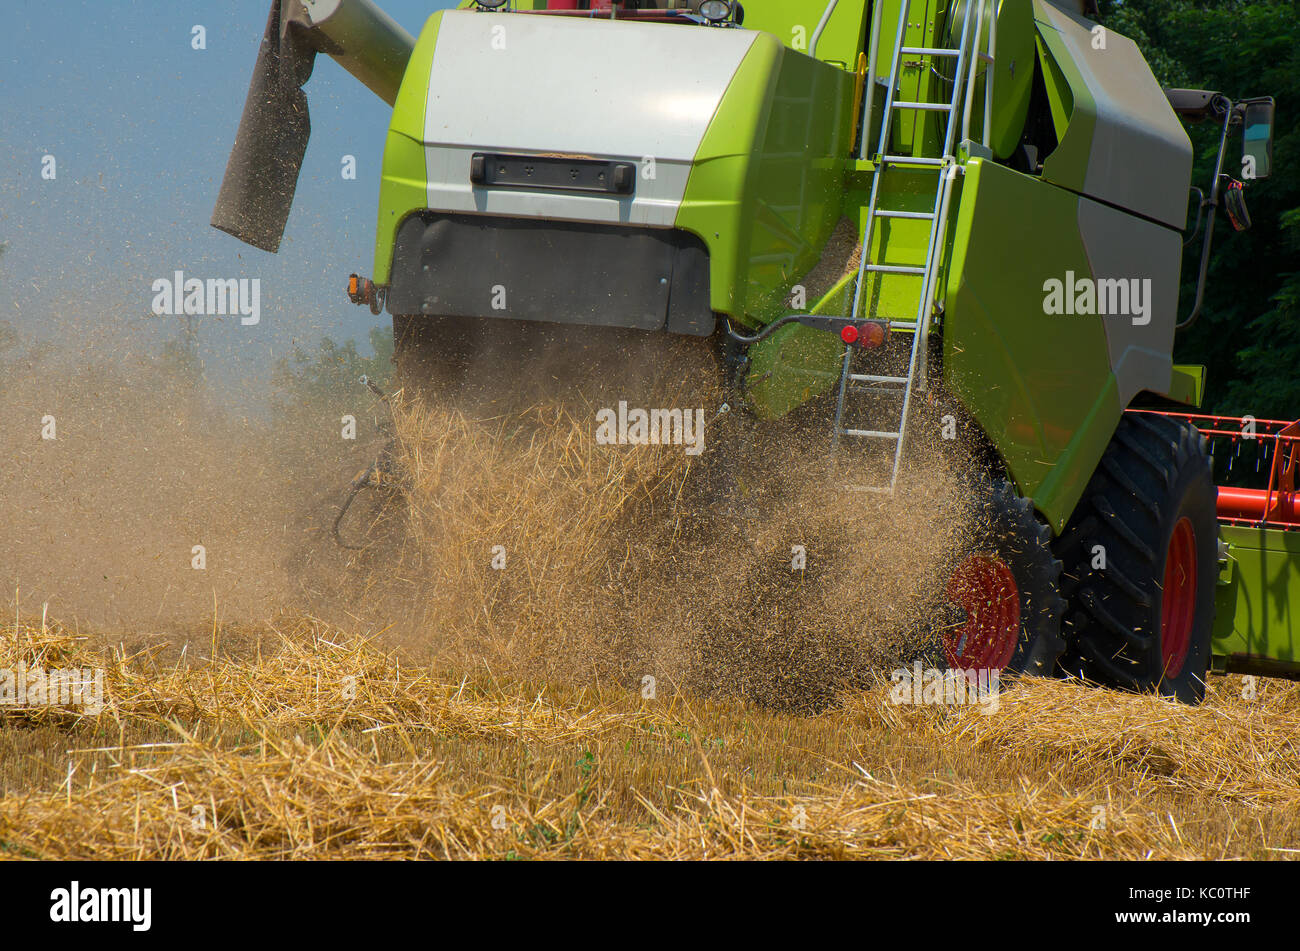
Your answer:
[1056,413,1218,703]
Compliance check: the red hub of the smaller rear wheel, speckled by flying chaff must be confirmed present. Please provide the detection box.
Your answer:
[944,555,1021,670]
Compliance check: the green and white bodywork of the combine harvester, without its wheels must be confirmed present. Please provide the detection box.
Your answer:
[215,0,1300,674]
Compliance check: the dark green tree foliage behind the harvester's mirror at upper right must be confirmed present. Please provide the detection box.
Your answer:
[1101,0,1300,420]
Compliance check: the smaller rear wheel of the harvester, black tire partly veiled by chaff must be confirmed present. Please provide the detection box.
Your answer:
[941,478,1065,677]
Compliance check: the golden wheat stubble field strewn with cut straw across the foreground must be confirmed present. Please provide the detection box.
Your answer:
[0,620,1300,859]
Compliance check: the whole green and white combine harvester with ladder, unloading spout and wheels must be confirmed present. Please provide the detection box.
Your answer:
[212,0,1300,703]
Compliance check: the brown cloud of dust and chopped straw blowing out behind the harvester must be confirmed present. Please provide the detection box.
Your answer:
[0,324,969,709]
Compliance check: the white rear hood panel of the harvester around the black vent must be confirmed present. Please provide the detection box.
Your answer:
[424,10,755,227]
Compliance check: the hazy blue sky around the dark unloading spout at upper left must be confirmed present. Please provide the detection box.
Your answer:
[0,0,455,408]
